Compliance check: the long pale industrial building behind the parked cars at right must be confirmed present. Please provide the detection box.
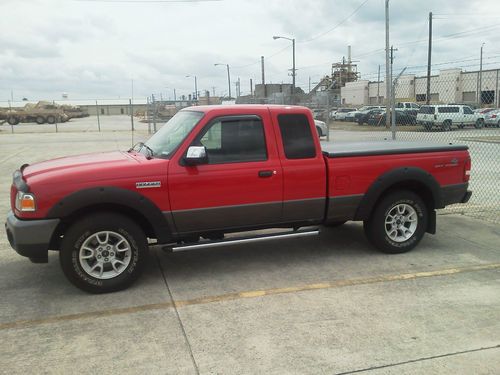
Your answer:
[341,69,500,107]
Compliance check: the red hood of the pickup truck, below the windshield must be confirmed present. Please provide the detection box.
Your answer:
[23,151,161,186]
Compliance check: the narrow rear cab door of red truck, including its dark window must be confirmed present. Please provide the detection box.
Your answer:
[273,111,326,223]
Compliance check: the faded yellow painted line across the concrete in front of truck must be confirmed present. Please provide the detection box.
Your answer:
[0,263,500,330]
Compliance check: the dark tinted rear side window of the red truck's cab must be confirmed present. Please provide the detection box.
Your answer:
[278,114,316,159]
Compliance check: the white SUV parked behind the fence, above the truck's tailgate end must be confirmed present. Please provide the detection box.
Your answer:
[417,104,484,131]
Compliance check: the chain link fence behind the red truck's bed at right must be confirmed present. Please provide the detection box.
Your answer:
[314,69,500,223]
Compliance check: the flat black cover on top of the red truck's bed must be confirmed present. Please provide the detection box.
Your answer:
[321,141,468,158]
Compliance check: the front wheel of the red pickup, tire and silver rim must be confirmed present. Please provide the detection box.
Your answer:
[59,212,148,294]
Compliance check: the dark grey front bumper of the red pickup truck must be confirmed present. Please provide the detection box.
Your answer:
[5,211,60,263]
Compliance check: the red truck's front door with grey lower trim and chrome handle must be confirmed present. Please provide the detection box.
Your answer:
[168,112,283,233]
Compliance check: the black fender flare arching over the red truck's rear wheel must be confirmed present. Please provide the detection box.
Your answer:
[354,167,443,220]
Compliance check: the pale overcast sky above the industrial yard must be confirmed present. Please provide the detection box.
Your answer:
[0,0,500,102]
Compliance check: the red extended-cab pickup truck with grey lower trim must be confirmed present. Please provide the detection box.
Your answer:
[5,105,471,293]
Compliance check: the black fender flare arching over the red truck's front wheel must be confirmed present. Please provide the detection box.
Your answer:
[47,186,171,243]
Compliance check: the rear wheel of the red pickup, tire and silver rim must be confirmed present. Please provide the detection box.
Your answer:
[363,190,429,254]
